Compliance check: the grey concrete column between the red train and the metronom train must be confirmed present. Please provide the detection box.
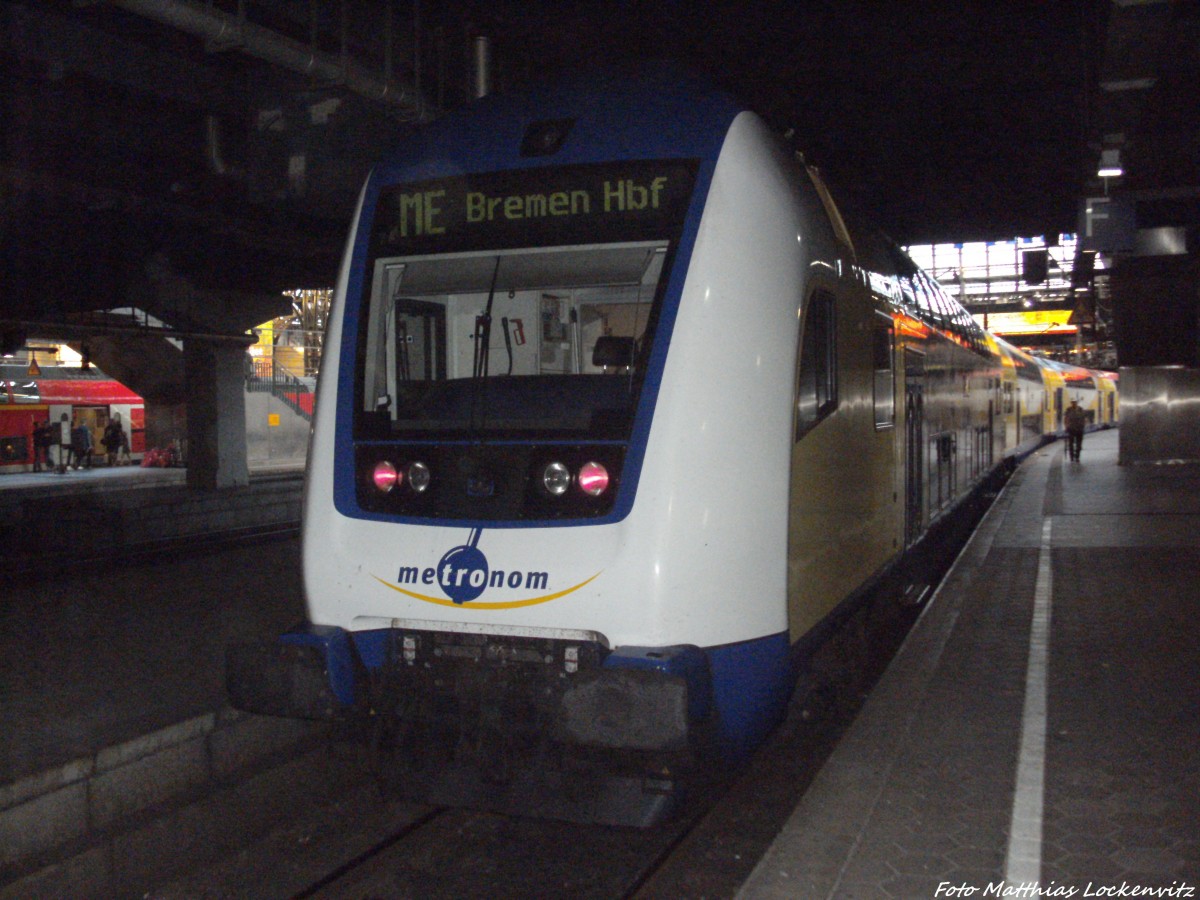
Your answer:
[184,341,250,490]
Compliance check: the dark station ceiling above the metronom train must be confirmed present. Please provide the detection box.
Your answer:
[0,0,1200,331]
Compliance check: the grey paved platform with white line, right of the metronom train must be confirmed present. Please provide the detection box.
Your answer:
[739,431,1200,900]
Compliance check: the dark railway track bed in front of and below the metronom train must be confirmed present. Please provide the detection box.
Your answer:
[144,585,916,900]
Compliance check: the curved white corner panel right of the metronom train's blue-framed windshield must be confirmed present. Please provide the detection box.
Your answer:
[624,115,809,647]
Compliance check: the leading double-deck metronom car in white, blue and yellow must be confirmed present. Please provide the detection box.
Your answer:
[227,71,1113,826]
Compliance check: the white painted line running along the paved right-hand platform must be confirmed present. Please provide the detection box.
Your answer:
[1004,517,1054,884]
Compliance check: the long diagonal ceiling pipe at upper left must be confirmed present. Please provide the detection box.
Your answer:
[110,0,427,121]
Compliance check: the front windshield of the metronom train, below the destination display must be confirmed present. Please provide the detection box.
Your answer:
[360,241,667,439]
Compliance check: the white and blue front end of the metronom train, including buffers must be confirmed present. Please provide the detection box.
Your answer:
[229,70,836,821]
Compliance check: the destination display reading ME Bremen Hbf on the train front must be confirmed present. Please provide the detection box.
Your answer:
[372,160,696,256]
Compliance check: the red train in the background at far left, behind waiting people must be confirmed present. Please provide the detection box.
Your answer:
[0,359,145,473]
